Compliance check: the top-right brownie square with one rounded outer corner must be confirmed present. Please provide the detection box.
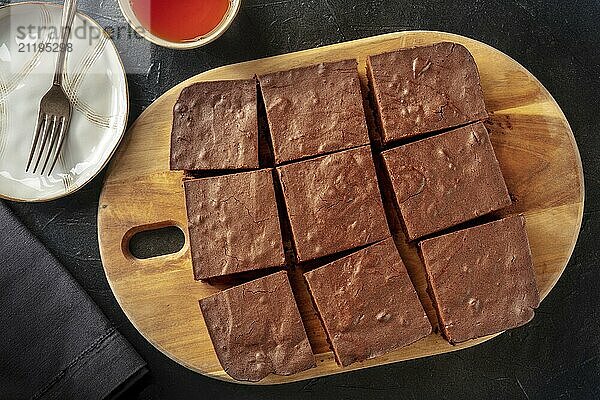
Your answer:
[367,42,488,144]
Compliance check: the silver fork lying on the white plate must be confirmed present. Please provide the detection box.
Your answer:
[25,0,77,176]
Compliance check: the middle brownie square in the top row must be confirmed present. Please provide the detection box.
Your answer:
[258,60,369,164]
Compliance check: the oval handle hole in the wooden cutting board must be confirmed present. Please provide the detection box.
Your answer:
[123,224,185,260]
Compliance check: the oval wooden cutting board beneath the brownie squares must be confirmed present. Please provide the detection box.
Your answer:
[98,31,584,384]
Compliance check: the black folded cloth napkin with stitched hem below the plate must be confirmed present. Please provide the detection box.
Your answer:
[0,202,146,400]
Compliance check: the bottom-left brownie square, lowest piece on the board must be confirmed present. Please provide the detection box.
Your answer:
[200,271,315,381]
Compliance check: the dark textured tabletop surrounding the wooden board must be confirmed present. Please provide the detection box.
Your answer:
[0,0,600,400]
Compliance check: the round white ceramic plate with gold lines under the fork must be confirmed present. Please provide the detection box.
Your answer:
[0,3,128,201]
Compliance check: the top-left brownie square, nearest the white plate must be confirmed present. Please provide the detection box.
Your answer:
[170,79,258,171]
